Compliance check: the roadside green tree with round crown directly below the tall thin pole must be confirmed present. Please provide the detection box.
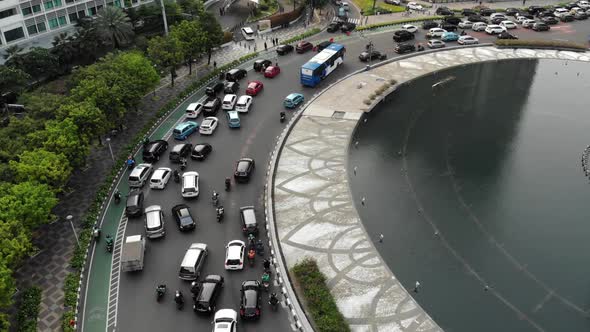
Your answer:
[148,36,184,86]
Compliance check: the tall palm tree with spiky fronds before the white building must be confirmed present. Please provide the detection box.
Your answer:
[95,6,134,49]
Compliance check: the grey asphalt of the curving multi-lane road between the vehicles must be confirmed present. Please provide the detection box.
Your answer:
[117,21,590,331]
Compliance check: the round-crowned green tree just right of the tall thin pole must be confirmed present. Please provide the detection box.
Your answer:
[170,21,206,75]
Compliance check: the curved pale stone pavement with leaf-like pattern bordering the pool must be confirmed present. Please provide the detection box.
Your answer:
[273,46,590,332]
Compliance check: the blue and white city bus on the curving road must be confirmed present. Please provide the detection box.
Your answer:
[301,44,346,87]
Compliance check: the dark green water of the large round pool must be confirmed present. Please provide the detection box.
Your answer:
[348,60,590,332]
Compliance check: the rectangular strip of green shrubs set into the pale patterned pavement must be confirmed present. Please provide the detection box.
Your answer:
[291,258,350,332]
